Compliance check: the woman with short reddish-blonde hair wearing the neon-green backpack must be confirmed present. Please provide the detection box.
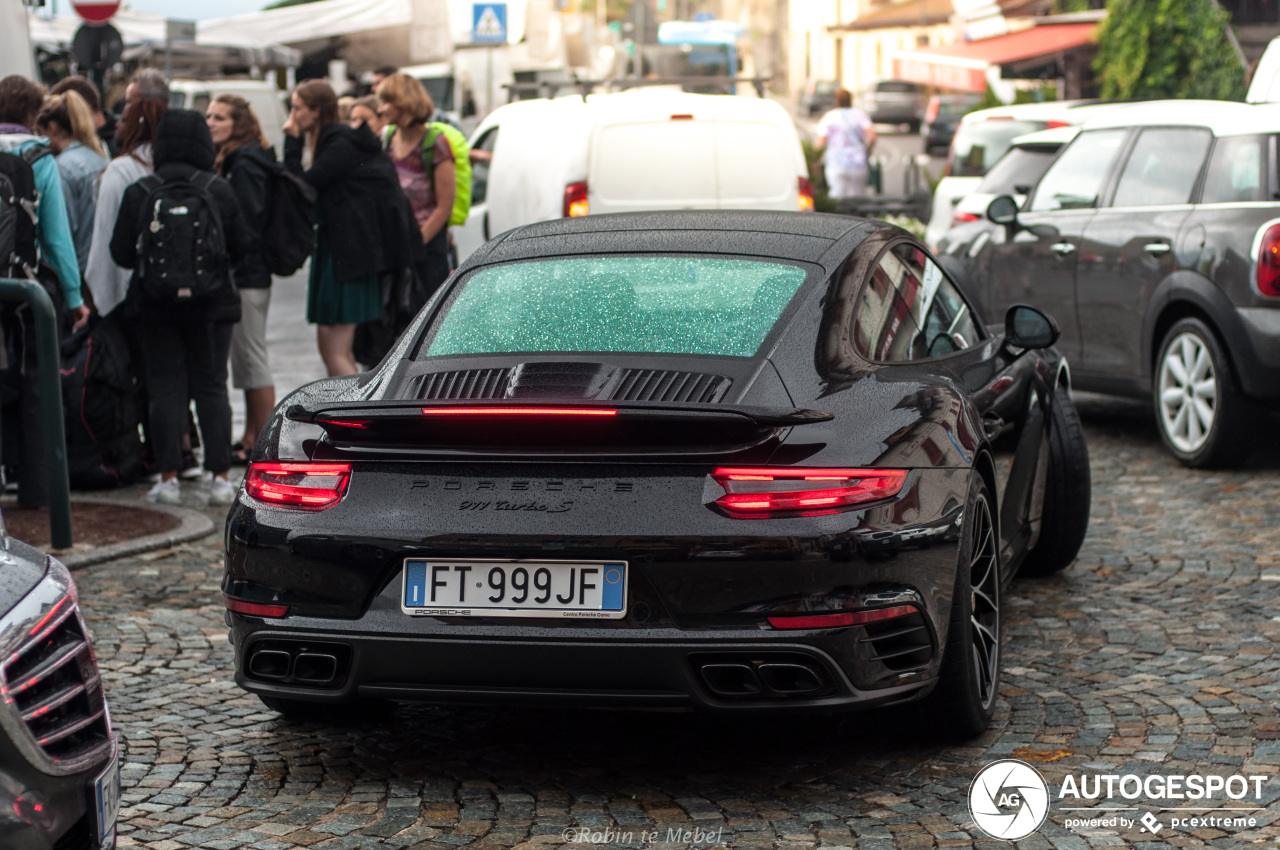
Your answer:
[378,74,457,303]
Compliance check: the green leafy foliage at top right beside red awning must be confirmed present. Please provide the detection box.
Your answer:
[1093,0,1245,100]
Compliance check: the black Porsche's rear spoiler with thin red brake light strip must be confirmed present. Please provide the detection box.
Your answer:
[284,399,835,457]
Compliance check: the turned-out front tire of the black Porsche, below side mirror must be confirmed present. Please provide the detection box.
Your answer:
[1021,387,1092,576]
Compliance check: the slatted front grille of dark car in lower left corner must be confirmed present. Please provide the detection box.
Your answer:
[4,608,110,763]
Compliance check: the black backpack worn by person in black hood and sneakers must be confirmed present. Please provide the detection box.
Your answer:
[138,172,230,306]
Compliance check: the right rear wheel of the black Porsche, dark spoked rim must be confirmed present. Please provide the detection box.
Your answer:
[925,471,1005,740]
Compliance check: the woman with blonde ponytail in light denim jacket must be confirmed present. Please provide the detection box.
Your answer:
[36,90,108,275]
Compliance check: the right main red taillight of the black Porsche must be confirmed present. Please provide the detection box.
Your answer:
[712,467,906,516]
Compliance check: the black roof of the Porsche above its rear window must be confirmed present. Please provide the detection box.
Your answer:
[475,210,890,264]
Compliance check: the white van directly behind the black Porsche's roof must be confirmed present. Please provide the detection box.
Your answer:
[453,90,813,260]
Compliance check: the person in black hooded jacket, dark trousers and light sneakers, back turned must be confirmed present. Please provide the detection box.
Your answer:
[111,109,257,504]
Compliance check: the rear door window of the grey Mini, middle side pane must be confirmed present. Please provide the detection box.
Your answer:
[1111,128,1213,206]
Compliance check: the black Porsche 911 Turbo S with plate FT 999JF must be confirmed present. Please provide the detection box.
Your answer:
[223,211,1089,734]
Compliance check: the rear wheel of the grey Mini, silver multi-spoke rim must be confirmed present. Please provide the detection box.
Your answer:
[1151,317,1254,469]
